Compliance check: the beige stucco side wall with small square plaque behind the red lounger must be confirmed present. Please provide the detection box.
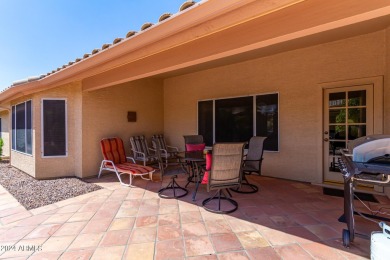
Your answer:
[82,79,164,177]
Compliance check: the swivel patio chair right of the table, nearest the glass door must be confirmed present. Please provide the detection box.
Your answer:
[232,136,267,193]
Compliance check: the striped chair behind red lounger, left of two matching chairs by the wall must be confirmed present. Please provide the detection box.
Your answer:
[130,135,157,165]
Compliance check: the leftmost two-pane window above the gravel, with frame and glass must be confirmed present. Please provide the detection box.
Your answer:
[11,100,32,154]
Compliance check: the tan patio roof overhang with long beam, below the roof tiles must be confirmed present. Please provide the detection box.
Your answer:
[0,0,390,102]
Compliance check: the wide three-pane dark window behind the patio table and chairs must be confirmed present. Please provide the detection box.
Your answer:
[198,93,279,151]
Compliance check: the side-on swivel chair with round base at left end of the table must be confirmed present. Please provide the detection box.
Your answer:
[152,139,188,199]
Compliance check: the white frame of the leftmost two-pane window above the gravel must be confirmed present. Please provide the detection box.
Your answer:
[11,99,34,156]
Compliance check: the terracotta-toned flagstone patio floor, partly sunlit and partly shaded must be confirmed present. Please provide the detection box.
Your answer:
[0,174,390,260]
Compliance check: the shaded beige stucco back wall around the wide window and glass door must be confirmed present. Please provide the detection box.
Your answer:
[164,31,389,183]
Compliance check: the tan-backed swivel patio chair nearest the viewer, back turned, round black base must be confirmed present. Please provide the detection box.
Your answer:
[202,143,245,213]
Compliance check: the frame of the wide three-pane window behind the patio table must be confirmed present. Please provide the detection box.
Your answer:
[196,92,280,153]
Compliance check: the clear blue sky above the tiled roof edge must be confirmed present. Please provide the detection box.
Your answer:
[0,0,199,90]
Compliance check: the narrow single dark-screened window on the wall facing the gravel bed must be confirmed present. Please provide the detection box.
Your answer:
[42,99,67,157]
